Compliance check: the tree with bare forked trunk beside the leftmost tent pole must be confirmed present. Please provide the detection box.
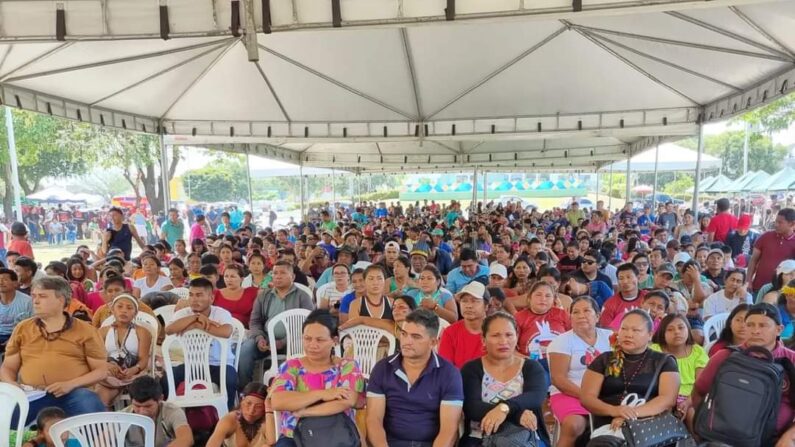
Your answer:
[95,128,181,214]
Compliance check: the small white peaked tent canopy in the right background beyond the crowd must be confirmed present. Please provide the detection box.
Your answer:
[601,143,721,172]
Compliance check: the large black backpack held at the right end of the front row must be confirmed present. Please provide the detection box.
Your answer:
[694,346,785,447]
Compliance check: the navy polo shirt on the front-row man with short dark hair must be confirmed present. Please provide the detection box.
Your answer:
[367,352,464,445]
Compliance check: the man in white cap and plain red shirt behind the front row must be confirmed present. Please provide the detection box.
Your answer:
[439,281,488,369]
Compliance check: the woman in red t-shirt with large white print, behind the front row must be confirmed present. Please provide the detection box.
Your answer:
[516,281,571,370]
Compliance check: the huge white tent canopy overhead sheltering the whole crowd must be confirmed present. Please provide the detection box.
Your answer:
[0,0,795,172]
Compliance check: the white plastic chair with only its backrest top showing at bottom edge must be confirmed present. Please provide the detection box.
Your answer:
[50,413,155,447]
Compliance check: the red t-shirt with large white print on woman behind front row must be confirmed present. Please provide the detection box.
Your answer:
[516,307,571,359]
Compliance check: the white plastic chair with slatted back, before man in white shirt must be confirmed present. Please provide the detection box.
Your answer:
[162,329,229,419]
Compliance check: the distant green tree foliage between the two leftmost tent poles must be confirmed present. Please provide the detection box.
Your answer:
[182,158,248,202]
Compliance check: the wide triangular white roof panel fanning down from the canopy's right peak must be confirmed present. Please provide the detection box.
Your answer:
[432,32,693,118]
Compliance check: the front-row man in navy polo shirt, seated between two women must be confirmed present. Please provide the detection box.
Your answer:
[367,309,464,447]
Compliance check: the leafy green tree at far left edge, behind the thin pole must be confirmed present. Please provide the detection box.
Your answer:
[0,107,99,220]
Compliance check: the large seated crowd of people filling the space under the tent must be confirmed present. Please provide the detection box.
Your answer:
[0,199,795,447]
